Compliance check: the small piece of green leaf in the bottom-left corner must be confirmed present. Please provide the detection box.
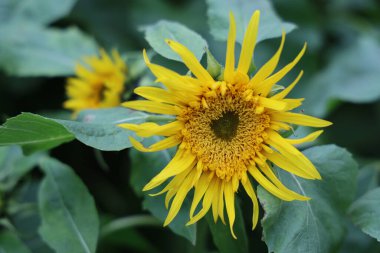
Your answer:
[0,230,31,253]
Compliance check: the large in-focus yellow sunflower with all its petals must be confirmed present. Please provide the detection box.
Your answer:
[120,11,331,238]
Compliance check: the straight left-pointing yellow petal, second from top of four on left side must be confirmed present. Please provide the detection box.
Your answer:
[122,100,180,115]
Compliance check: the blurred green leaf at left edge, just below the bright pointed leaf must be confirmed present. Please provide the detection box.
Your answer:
[0,146,43,192]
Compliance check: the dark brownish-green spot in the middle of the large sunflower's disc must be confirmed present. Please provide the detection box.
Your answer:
[210,111,239,141]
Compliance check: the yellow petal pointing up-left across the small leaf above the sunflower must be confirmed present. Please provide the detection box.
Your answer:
[166,40,214,83]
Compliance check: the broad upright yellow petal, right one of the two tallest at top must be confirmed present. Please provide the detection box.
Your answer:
[237,11,260,74]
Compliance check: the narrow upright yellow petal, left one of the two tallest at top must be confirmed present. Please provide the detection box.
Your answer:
[224,12,236,82]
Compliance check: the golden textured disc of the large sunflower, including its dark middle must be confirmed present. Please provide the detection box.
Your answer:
[178,87,270,182]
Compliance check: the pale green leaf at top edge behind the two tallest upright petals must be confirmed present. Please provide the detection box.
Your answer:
[206,0,296,43]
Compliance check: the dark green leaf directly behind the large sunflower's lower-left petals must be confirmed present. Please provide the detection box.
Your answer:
[130,137,196,244]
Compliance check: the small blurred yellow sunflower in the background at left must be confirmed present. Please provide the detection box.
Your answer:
[63,49,127,114]
